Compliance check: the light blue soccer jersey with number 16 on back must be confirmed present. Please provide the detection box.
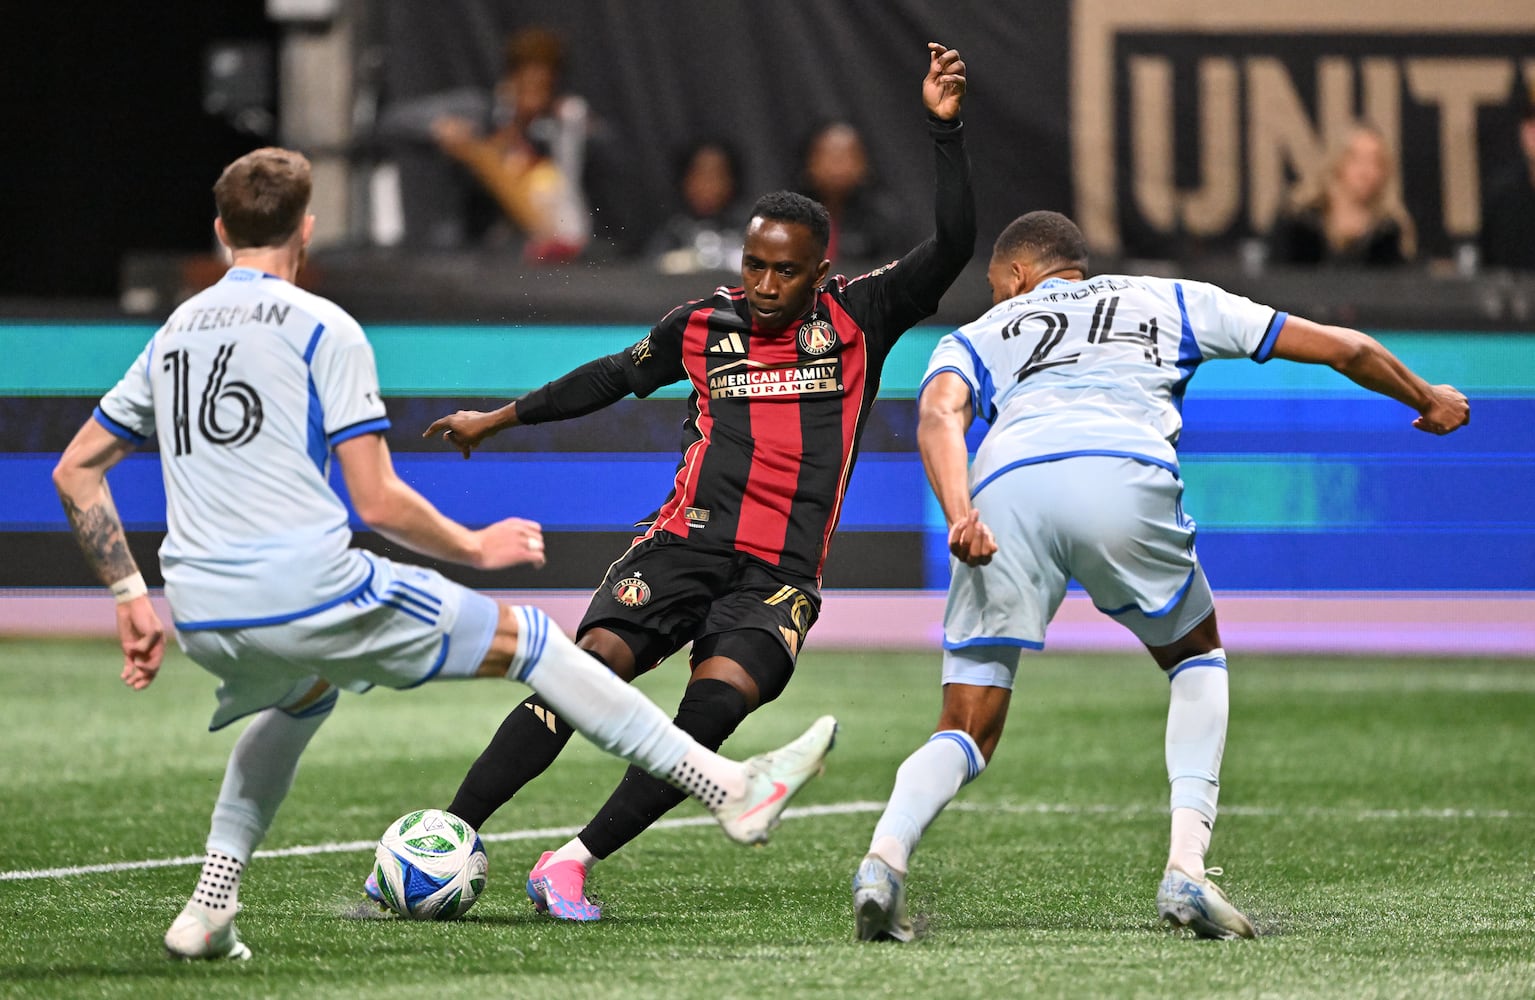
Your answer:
[95,267,388,630]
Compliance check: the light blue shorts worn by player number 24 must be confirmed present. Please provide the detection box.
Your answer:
[944,455,1214,688]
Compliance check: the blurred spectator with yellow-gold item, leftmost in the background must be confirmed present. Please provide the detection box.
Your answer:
[379,28,594,261]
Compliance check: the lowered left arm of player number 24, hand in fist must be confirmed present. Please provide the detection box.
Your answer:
[916,372,996,565]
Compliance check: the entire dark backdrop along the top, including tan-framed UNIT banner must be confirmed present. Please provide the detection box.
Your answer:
[373,0,1535,258]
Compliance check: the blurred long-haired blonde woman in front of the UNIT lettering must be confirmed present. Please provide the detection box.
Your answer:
[1269,123,1417,267]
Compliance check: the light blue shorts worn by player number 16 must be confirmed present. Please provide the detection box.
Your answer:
[177,553,500,730]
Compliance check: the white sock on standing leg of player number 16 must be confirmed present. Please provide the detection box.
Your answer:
[207,693,336,863]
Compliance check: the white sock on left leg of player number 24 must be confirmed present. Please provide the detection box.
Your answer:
[869,730,985,874]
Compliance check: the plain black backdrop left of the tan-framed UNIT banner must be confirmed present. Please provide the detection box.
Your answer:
[373,0,1071,262]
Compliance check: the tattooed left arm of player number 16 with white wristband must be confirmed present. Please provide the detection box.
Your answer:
[54,421,166,690]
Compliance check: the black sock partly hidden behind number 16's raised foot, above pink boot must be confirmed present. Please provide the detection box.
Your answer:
[580,677,748,860]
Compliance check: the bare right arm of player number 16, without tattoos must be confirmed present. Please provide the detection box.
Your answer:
[336,435,543,570]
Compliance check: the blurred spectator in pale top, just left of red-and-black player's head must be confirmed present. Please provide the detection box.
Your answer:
[645,138,749,275]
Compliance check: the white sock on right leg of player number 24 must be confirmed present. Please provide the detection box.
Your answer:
[1167,648,1230,877]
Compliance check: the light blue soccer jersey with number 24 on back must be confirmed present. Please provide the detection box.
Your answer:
[923,275,1286,493]
